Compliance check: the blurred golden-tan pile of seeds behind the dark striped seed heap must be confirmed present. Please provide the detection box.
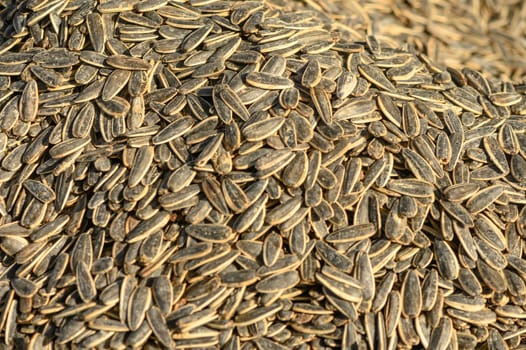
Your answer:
[360,0,526,82]
